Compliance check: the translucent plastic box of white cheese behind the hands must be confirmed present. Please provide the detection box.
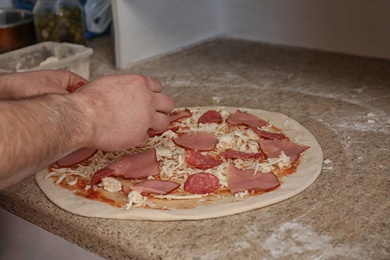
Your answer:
[0,42,93,79]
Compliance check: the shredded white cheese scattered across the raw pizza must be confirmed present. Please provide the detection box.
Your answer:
[46,108,306,210]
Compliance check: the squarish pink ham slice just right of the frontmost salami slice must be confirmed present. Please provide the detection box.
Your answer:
[227,164,280,194]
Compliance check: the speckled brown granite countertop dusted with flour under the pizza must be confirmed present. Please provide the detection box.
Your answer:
[0,37,390,259]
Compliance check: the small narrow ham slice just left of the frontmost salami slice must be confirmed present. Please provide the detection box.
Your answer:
[122,180,180,195]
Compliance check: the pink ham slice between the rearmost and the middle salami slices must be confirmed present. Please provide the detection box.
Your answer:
[172,132,218,151]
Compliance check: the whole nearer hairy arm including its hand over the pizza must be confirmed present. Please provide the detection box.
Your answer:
[0,75,174,189]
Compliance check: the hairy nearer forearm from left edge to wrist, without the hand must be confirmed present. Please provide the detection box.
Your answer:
[0,95,90,189]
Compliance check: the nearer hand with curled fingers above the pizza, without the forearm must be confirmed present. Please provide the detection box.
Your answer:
[71,75,174,151]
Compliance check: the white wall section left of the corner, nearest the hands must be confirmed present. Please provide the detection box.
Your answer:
[112,0,222,68]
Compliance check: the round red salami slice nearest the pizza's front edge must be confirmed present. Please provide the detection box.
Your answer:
[184,172,219,194]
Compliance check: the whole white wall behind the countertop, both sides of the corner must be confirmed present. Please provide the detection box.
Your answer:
[112,0,390,68]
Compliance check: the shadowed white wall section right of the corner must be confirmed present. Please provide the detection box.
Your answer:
[222,0,390,58]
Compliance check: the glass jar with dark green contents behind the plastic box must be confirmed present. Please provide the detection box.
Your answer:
[33,0,86,45]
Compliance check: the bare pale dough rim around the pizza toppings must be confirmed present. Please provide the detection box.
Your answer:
[35,107,323,221]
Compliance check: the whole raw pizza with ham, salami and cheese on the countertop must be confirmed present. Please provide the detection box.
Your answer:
[36,107,322,220]
